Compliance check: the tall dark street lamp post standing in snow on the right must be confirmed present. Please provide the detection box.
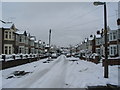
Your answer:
[93,2,108,78]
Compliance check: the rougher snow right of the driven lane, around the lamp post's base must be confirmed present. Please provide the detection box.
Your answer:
[66,60,118,88]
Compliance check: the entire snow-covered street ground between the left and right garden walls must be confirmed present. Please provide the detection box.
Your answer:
[2,55,118,88]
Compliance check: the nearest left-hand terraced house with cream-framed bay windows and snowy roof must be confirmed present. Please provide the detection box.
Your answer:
[0,22,16,54]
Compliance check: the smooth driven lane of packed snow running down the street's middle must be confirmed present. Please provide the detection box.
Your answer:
[19,56,67,88]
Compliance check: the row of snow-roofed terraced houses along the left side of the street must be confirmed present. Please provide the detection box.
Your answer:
[0,21,44,54]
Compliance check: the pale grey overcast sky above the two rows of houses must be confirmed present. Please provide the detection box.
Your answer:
[2,2,118,46]
